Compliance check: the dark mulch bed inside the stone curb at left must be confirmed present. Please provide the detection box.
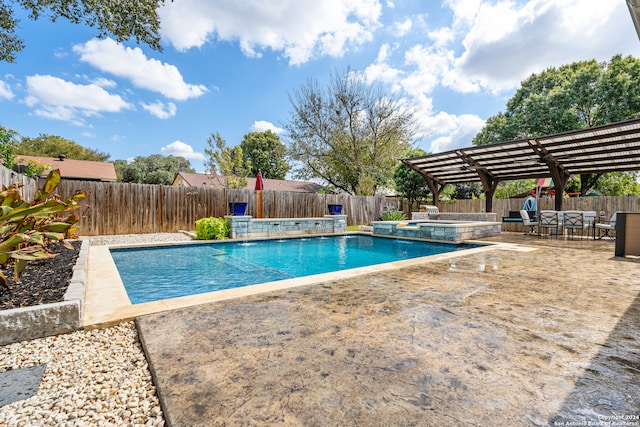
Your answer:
[0,241,81,310]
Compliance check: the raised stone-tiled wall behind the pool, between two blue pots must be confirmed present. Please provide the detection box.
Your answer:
[225,215,347,239]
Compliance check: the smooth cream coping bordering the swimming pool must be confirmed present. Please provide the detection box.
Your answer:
[83,233,523,329]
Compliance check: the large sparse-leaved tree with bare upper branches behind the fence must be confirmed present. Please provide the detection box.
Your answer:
[285,70,415,195]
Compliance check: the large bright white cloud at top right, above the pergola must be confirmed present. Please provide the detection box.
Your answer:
[444,0,638,92]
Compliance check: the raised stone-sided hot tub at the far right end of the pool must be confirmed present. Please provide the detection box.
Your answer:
[372,220,502,243]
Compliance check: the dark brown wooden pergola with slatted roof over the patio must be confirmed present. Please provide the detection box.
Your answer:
[401,119,640,212]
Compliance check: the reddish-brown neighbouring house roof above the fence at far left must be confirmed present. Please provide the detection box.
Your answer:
[15,154,117,182]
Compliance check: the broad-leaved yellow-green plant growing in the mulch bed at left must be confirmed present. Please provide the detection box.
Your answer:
[0,169,86,287]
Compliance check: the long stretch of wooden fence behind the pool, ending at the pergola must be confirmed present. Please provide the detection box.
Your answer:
[52,180,398,236]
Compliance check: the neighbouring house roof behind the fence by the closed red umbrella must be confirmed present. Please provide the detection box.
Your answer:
[172,172,322,193]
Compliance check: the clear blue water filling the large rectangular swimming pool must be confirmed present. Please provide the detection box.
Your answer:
[111,235,475,304]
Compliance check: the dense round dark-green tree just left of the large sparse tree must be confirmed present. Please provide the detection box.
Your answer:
[240,130,291,179]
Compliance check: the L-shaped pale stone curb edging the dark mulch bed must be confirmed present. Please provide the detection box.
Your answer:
[0,240,89,345]
